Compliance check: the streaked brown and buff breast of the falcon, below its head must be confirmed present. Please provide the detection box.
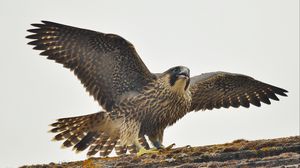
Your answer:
[118,80,191,135]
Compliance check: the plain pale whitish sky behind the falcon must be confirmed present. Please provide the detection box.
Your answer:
[0,0,299,167]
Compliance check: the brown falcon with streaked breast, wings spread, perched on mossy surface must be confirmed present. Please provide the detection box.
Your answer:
[27,21,287,156]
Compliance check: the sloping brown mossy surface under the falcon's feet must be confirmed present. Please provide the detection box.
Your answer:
[22,136,300,168]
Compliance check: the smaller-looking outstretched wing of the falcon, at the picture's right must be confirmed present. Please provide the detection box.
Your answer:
[190,72,287,111]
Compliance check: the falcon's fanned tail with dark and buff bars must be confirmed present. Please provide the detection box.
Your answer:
[50,111,149,157]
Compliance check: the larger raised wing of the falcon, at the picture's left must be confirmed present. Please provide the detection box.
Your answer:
[27,21,155,111]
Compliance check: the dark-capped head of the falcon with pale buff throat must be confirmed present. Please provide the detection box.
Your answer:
[164,66,190,91]
